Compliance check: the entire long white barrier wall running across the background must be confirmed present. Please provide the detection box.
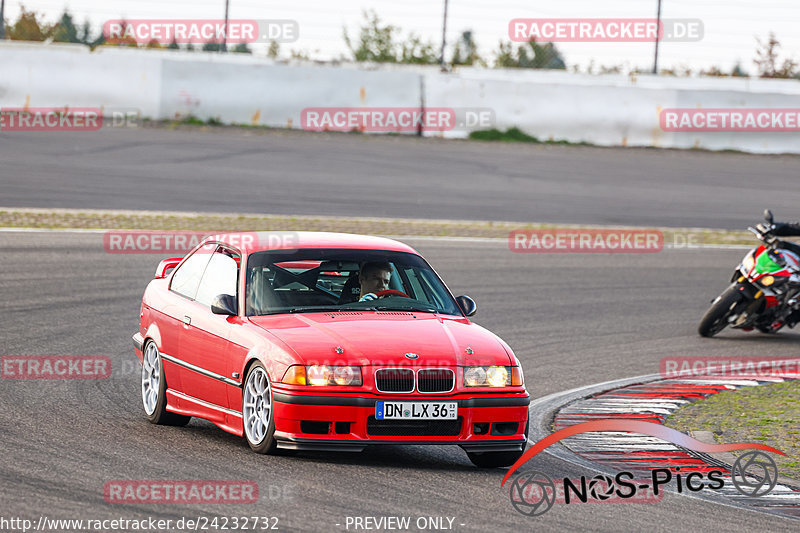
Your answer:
[0,41,800,153]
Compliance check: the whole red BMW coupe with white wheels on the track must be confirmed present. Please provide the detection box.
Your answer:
[133,232,530,467]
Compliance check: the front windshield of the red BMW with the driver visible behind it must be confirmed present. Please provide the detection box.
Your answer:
[245,248,461,316]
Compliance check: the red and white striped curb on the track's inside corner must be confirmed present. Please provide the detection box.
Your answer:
[553,376,800,517]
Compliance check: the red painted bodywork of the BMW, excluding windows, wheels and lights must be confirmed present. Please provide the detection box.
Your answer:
[134,232,530,449]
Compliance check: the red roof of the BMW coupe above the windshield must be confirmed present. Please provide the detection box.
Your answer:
[205,231,419,255]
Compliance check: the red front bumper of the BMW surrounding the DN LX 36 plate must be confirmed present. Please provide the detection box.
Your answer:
[272,389,530,452]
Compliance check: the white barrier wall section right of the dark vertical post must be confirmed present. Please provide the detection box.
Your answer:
[425,69,800,153]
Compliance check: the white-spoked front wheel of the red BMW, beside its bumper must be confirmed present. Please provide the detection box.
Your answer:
[242,362,277,453]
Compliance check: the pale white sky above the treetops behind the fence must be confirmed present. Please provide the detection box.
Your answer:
[5,0,800,74]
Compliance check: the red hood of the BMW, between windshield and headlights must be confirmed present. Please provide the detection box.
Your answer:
[250,311,513,366]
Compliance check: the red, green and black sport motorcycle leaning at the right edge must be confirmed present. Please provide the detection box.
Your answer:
[697,209,800,337]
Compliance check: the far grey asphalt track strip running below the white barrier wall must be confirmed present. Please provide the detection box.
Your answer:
[0,128,800,229]
